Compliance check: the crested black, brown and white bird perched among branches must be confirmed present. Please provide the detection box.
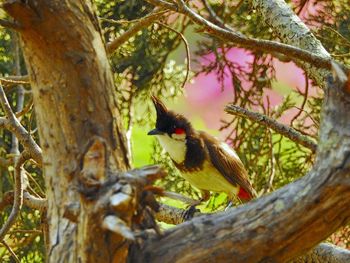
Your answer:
[148,95,257,205]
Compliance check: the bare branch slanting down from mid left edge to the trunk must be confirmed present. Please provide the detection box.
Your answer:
[0,82,42,164]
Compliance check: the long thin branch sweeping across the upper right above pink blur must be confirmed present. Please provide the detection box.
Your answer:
[147,0,332,70]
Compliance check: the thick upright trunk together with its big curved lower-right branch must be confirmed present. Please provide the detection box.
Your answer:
[4,0,350,262]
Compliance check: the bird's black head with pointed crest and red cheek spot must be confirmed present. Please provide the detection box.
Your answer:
[148,96,192,136]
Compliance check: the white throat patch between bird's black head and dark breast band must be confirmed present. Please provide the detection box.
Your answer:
[156,134,186,163]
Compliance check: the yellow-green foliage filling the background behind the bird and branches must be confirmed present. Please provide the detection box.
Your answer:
[0,0,350,262]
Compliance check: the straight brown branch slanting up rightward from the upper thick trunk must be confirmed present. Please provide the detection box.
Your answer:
[106,8,168,55]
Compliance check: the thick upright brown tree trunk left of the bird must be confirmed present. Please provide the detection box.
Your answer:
[4,0,128,262]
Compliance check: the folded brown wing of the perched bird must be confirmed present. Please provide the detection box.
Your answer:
[201,132,256,197]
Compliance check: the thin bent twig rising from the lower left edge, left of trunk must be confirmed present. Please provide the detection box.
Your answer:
[0,151,30,240]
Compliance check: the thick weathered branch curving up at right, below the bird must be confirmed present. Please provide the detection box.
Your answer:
[132,79,350,263]
